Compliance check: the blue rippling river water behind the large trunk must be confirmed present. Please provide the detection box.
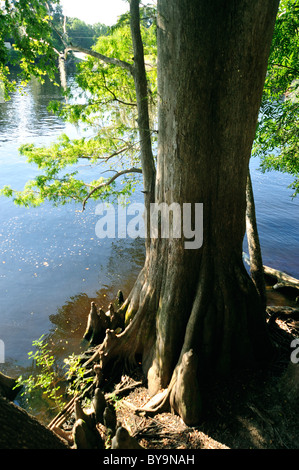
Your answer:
[0,73,299,396]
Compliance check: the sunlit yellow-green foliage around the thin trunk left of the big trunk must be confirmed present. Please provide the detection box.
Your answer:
[0,5,157,207]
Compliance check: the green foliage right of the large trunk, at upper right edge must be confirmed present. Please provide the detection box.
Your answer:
[253,0,299,196]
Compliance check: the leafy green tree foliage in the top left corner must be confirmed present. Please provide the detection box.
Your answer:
[0,0,109,99]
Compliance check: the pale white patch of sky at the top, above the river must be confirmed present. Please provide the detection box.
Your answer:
[60,0,129,26]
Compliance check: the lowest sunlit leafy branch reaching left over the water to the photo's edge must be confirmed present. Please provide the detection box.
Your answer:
[0,131,141,207]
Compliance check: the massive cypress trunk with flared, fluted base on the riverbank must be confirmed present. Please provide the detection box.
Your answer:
[101,0,279,424]
